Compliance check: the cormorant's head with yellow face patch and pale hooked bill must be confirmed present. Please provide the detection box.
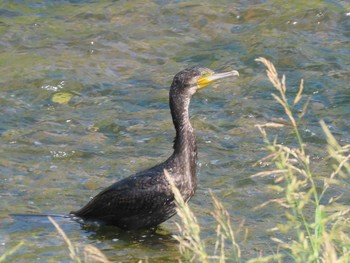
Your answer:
[171,67,239,95]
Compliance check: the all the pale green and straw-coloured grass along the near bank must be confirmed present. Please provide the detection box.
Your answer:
[0,58,350,263]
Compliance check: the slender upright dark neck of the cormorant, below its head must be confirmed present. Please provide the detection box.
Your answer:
[170,94,197,163]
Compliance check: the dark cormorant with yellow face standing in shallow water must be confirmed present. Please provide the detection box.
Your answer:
[70,67,239,229]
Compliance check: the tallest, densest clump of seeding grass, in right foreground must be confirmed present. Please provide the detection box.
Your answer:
[255,58,350,262]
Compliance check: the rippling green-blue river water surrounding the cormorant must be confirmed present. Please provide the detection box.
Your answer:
[0,0,350,262]
